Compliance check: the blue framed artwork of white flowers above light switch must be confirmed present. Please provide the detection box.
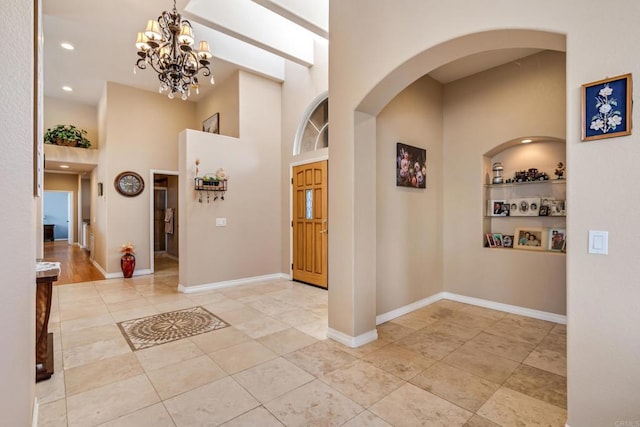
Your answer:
[582,74,632,141]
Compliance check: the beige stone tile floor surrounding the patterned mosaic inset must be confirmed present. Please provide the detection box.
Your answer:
[36,262,566,427]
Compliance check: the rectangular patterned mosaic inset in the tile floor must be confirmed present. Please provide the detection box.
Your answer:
[118,307,229,351]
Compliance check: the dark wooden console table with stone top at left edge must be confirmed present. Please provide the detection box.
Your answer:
[36,262,60,382]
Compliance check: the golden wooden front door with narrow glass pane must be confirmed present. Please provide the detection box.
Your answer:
[292,160,328,288]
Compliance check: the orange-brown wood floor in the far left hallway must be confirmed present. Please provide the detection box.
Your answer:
[43,241,104,286]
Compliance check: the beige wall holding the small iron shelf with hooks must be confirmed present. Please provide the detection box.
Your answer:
[179,72,283,288]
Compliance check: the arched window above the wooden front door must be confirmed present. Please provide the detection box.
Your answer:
[293,93,329,156]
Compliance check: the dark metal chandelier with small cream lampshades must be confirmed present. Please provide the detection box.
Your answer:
[133,0,214,100]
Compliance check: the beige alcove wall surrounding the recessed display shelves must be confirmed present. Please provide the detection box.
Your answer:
[443,51,566,315]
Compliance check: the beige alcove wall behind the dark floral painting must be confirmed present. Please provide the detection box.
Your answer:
[372,76,443,315]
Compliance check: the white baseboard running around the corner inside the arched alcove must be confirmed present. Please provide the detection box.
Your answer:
[376,292,567,325]
